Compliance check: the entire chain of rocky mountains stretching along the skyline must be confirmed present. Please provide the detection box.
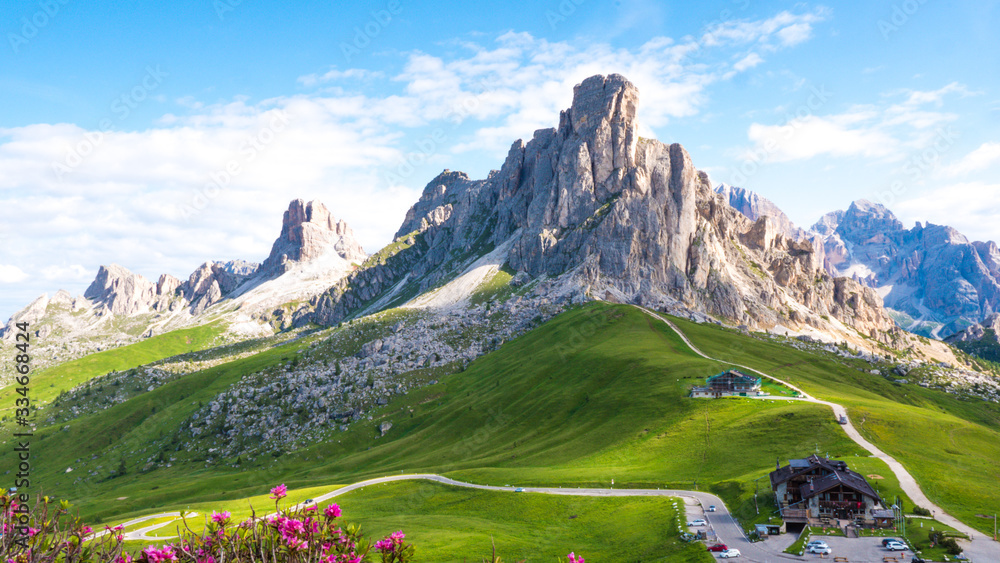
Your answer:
[4,75,984,372]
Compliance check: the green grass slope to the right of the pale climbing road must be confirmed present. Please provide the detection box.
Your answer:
[672,319,1000,533]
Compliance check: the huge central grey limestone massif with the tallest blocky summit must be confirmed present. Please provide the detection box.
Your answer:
[315,75,894,342]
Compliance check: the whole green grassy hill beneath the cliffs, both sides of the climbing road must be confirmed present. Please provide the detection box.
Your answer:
[7,303,1000,552]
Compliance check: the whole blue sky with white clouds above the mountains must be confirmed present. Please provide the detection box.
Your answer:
[0,0,1000,318]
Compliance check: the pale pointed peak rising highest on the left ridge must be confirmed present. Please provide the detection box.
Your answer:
[260,199,367,277]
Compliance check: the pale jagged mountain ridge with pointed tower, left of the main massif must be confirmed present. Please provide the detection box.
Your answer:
[0,199,366,370]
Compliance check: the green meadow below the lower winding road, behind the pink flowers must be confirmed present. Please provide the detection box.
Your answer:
[133,481,712,563]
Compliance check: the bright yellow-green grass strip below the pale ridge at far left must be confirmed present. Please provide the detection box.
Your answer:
[0,323,224,404]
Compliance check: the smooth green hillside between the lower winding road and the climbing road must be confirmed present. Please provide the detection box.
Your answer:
[66,304,860,518]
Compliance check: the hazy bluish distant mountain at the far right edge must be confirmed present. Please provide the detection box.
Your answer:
[813,200,1000,337]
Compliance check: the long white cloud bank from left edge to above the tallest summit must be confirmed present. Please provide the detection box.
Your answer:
[0,11,825,320]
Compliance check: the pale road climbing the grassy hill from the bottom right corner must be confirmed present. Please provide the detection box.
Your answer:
[635,306,1000,563]
